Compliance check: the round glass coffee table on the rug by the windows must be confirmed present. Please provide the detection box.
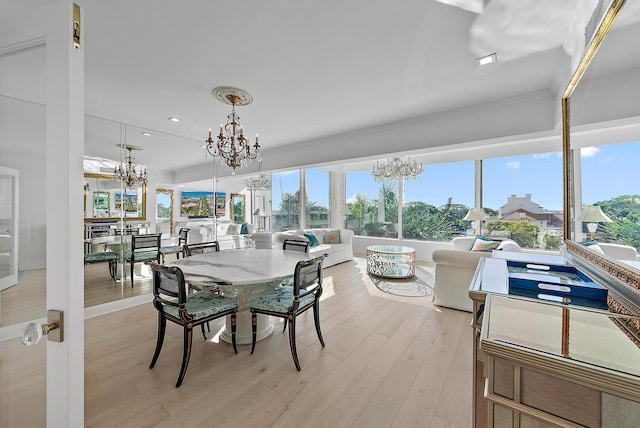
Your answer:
[367,245,416,278]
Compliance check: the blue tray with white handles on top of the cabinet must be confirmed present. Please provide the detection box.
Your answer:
[507,261,607,302]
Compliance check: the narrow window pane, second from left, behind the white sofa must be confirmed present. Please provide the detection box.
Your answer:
[305,168,329,229]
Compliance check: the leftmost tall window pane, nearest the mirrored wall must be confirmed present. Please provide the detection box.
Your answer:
[271,170,300,231]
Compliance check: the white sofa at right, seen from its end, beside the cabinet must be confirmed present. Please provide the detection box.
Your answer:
[431,236,522,312]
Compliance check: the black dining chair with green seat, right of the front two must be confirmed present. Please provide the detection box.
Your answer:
[249,255,325,371]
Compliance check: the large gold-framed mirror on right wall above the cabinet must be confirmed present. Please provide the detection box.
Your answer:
[562,1,640,340]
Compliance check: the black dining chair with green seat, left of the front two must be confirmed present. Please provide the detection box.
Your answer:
[149,263,238,388]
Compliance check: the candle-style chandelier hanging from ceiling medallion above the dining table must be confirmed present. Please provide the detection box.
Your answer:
[205,87,262,173]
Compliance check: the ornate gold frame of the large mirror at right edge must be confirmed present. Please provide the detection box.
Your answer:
[562,0,640,346]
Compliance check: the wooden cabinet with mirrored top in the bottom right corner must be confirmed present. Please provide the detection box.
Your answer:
[470,259,640,428]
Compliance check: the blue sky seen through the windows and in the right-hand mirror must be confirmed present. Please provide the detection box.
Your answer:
[273,141,640,210]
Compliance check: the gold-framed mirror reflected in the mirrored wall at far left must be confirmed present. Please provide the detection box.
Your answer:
[84,173,147,222]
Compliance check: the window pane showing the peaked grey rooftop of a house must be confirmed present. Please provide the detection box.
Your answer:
[482,152,563,250]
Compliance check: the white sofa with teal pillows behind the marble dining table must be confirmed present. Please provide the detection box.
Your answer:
[252,228,353,267]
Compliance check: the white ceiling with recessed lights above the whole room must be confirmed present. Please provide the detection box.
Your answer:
[0,0,640,185]
